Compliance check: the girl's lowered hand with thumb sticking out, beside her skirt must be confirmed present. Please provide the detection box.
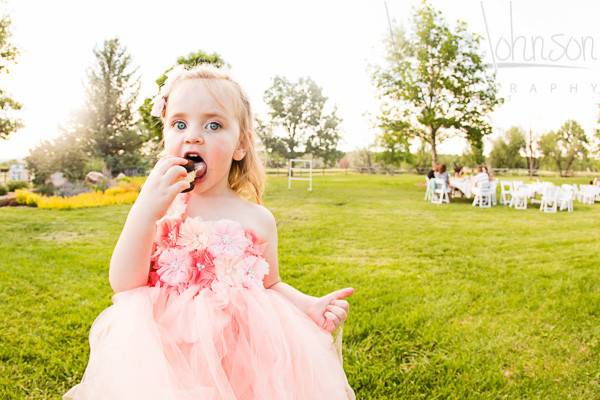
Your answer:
[306,288,354,333]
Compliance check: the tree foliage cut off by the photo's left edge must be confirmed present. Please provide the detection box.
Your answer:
[0,11,23,140]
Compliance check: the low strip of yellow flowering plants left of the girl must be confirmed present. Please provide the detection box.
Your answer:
[15,176,146,209]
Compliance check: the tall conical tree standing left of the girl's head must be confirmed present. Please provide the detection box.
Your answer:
[81,38,147,174]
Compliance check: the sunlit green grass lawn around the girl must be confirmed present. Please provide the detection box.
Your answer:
[0,175,600,399]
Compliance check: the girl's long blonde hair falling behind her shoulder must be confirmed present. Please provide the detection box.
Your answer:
[159,64,265,204]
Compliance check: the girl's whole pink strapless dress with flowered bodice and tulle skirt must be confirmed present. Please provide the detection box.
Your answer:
[63,193,355,400]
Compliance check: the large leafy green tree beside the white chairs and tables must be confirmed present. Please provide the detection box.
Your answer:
[373,2,502,166]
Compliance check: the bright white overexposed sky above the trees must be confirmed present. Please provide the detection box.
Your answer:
[0,0,600,160]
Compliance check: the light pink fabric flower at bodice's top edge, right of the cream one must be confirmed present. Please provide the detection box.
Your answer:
[208,219,251,258]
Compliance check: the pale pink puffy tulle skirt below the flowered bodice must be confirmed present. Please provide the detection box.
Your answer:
[63,285,354,400]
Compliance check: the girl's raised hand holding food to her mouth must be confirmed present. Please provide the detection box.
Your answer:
[135,156,190,220]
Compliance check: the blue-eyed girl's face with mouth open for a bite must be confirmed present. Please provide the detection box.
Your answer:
[163,79,240,193]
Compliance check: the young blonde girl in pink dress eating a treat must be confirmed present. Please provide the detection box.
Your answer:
[63,66,354,400]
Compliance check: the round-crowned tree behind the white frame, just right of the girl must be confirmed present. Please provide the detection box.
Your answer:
[264,76,341,163]
